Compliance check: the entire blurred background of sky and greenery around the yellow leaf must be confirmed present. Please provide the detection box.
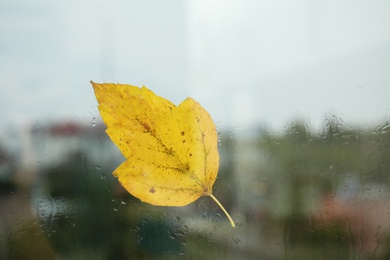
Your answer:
[0,0,390,259]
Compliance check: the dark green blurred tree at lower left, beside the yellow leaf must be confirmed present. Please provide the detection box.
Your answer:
[39,151,136,258]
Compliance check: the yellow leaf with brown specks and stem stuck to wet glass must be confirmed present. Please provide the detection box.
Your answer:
[91,81,235,227]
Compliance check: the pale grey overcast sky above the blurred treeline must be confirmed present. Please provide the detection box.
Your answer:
[0,0,390,138]
